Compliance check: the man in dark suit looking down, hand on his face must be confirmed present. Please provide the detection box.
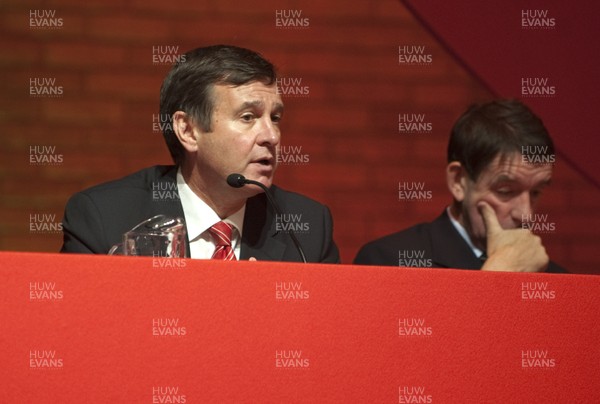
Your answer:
[354,100,566,272]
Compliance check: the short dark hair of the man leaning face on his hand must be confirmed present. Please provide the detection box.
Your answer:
[448,100,554,181]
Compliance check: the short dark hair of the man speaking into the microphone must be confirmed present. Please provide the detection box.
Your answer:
[160,45,277,164]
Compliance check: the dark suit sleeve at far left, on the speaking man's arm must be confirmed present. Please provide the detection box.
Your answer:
[60,193,108,254]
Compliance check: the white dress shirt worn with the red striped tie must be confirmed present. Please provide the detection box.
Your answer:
[177,168,246,260]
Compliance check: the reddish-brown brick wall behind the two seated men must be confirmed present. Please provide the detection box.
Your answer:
[0,0,600,273]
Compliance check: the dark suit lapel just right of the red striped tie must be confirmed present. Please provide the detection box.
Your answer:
[240,193,286,261]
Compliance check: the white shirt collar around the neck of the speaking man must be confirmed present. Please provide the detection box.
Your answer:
[177,167,246,242]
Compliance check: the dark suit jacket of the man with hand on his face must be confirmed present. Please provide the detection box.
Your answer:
[354,209,566,273]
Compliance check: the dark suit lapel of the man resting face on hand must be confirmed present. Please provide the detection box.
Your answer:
[431,210,483,269]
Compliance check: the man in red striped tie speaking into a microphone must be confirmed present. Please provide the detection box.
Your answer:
[61,45,340,263]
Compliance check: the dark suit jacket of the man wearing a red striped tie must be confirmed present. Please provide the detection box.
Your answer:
[61,166,340,263]
